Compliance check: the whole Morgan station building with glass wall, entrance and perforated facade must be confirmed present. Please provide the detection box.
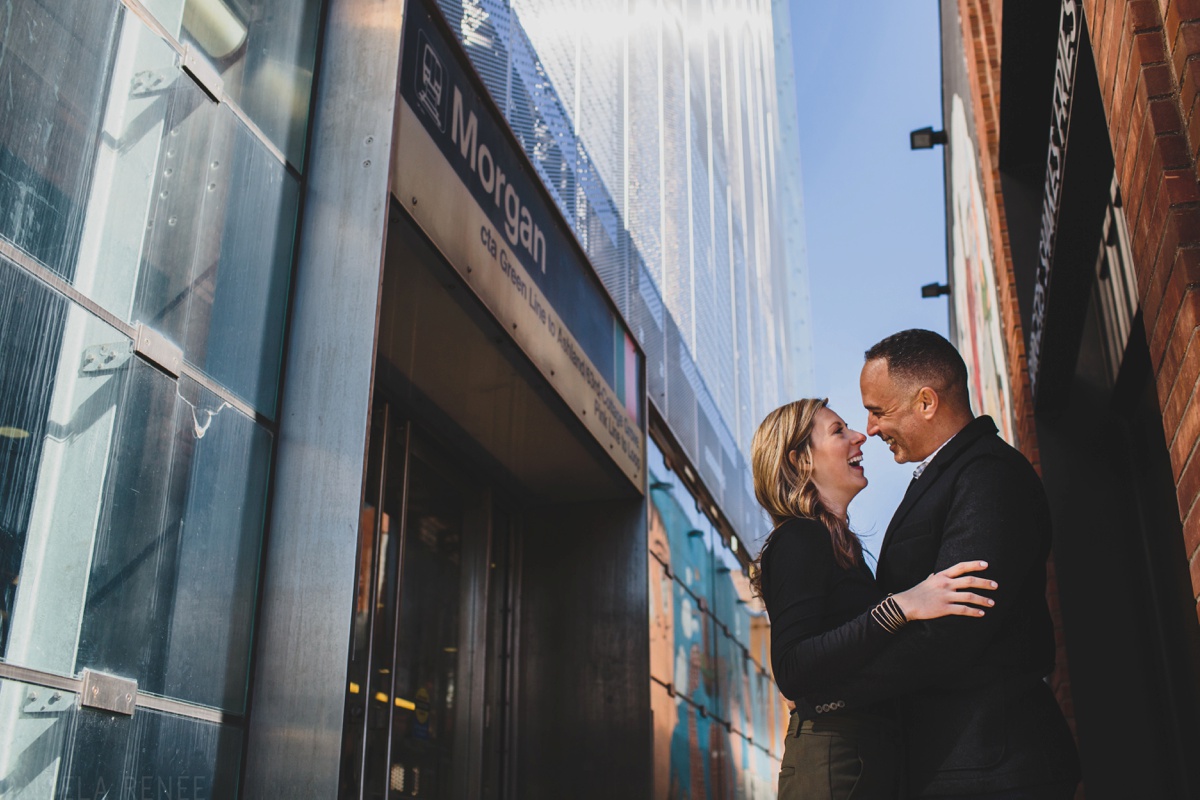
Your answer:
[0,0,811,798]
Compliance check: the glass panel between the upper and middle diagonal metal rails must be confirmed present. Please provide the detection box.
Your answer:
[0,0,299,416]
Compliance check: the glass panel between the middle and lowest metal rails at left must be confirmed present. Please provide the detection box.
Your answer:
[0,250,271,705]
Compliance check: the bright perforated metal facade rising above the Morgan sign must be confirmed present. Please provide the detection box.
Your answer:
[439,0,811,540]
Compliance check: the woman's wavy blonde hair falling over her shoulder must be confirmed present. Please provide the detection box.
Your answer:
[750,398,863,595]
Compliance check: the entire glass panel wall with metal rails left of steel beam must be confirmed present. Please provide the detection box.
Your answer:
[0,0,320,798]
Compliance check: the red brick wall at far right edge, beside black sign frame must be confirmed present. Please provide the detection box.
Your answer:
[1084,0,1200,612]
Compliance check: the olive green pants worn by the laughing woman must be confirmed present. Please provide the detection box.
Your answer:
[779,711,901,800]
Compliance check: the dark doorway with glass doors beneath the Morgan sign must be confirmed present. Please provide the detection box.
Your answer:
[340,401,515,800]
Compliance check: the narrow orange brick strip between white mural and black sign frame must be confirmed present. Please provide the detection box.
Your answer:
[959,0,1084,767]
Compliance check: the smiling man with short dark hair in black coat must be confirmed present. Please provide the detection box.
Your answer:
[802,330,1079,800]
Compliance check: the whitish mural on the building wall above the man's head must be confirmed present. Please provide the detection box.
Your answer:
[949,94,1018,446]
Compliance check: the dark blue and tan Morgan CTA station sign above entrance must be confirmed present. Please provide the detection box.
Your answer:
[391,0,646,487]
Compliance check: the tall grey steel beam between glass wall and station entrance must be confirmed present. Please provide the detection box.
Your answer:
[242,0,404,800]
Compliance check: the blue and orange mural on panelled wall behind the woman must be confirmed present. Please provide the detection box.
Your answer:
[648,444,787,800]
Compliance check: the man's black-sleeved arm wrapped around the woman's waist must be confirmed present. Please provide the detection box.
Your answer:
[805,456,1049,708]
